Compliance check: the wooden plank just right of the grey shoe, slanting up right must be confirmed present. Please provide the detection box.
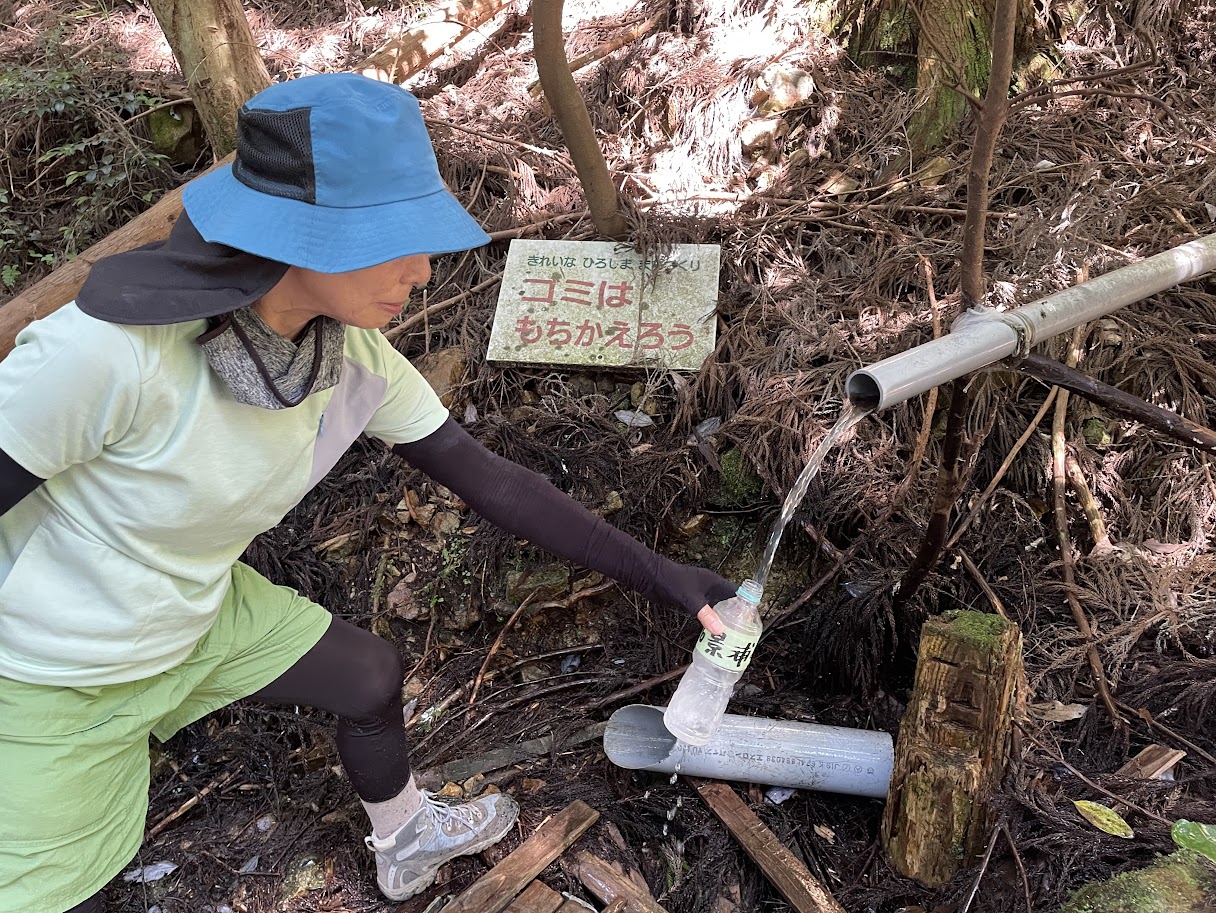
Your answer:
[440,799,599,913]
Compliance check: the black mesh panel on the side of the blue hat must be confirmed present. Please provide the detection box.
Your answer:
[232,107,316,203]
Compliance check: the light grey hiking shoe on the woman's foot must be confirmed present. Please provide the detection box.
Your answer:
[367,790,519,901]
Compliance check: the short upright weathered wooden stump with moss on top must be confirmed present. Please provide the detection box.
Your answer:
[883,612,1026,887]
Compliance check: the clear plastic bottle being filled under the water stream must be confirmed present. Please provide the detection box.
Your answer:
[663,580,764,745]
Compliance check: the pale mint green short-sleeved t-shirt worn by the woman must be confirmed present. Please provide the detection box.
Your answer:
[0,304,447,687]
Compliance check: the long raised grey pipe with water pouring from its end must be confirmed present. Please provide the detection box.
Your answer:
[845,235,1216,408]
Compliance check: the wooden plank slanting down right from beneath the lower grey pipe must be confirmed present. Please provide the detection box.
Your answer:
[693,779,845,913]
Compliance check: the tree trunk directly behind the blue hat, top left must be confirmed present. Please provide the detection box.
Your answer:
[151,0,270,158]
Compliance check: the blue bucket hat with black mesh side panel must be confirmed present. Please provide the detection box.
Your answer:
[182,73,490,272]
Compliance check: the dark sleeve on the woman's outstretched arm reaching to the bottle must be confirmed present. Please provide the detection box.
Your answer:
[393,418,734,615]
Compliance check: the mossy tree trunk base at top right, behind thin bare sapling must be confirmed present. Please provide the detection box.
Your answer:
[849,0,1034,157]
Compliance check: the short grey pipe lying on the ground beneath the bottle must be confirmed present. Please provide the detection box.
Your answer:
[604,704,895,799]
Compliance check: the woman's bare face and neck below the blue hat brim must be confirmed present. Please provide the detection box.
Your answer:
[255,254,430,338]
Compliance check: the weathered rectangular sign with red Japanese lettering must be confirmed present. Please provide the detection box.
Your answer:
[486,241,721,371]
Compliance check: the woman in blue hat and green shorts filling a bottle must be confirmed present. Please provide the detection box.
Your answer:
[0,74,732,913]
